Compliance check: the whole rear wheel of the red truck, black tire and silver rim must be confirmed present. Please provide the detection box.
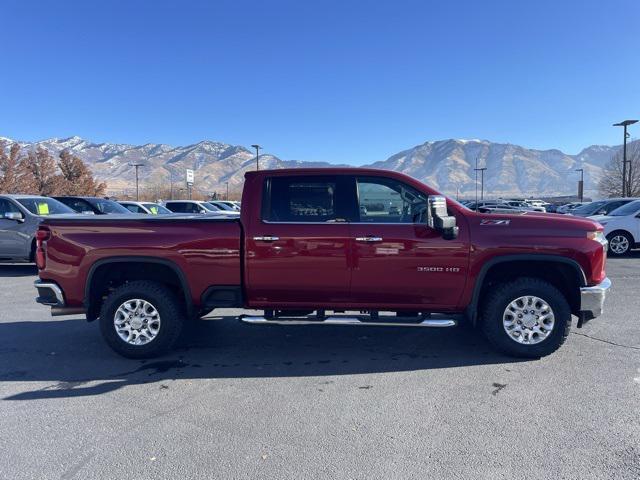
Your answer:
[100,280,185,358]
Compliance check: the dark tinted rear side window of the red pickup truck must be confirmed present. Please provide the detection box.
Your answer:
[262,177,338,223]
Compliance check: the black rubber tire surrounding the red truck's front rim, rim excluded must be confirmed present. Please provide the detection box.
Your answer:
[481,278,571,358]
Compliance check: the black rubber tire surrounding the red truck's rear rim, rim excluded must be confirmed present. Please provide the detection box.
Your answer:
[99,280,185,358]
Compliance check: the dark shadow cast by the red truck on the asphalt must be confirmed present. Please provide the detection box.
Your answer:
[0,317,518,400]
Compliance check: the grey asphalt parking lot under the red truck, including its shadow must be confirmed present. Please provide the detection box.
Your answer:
[0,254,640,480]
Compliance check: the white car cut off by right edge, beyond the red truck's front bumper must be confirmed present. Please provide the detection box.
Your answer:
[589,200,640,257]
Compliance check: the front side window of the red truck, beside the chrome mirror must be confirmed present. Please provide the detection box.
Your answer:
[357,177,427,223]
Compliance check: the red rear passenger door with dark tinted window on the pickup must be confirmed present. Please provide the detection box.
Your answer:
[245,175,351,307]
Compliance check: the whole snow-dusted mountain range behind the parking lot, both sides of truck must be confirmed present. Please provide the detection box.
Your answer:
[0,136,620,198]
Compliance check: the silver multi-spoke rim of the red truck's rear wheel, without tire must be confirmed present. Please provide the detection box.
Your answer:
[113,298,160,345]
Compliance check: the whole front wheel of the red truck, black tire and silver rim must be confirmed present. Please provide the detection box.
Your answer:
[481,278,571,358]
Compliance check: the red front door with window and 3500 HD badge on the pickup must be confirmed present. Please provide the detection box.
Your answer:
[351,176,468,311]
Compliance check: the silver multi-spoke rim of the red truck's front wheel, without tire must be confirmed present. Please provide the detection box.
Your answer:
[502,295,555,345]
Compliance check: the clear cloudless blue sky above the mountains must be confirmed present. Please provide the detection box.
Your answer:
[0,0,640,164]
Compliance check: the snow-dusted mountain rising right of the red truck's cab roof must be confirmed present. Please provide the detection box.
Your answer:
[372,140,620,197]
